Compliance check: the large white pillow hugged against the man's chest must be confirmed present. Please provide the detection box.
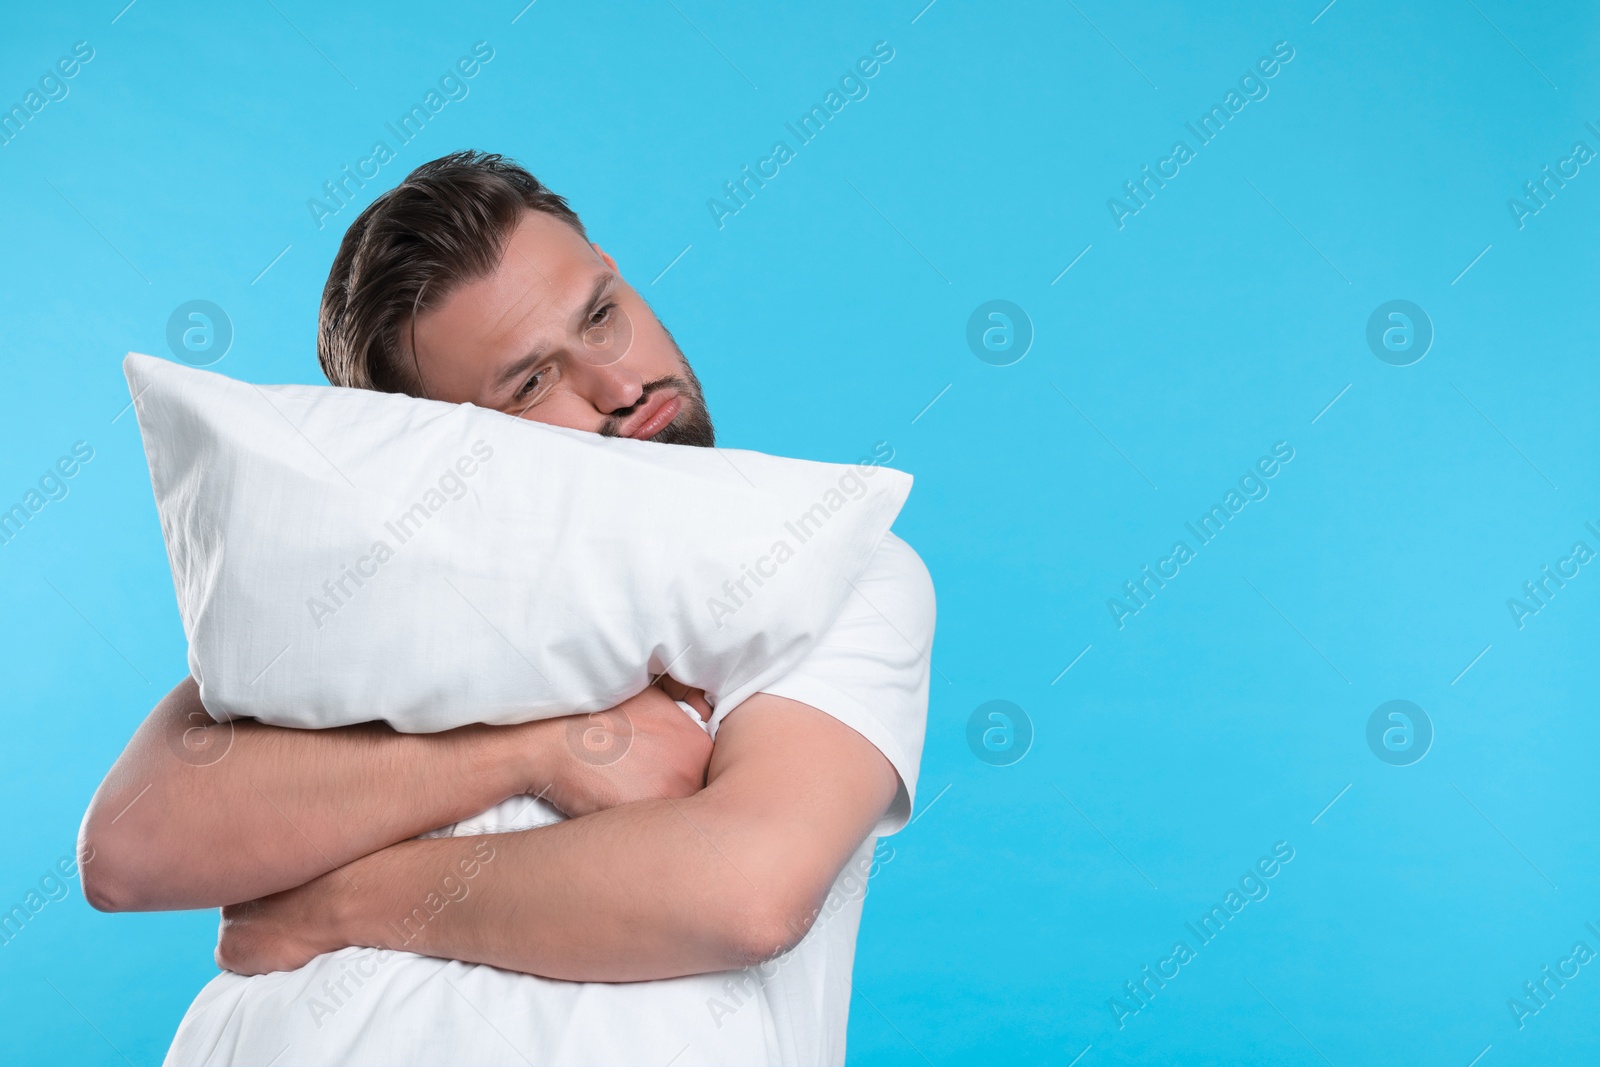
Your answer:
[123,354,912,733]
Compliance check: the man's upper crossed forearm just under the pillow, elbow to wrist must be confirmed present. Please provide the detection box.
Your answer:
[82,680,526,910]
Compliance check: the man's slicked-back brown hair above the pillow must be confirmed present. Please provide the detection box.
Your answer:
[317,150,589,394]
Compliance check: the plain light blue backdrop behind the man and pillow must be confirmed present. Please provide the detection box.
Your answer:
[0,0,1600,1067]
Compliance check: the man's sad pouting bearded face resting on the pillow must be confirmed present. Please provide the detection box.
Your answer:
[402,211,714,446]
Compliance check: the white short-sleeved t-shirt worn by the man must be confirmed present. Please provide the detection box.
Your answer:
[166,534,934,1067]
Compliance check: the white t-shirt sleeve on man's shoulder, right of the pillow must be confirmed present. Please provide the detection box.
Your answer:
[720,534,934,837]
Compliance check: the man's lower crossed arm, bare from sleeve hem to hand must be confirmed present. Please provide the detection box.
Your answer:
[218,694,898,982]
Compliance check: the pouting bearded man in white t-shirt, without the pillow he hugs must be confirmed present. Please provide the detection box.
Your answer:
[80,152,934,1067]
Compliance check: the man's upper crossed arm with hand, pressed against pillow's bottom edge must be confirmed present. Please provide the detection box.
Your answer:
[78,678,710,910]
